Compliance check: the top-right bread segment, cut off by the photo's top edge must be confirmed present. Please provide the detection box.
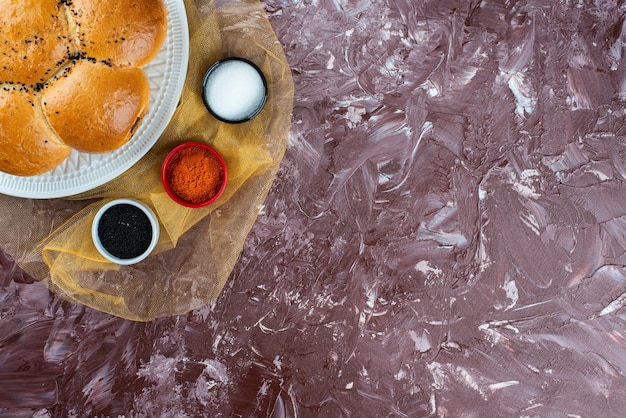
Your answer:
[68,0,167,66]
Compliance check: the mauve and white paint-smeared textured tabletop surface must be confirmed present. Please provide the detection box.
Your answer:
[0,0,626,417]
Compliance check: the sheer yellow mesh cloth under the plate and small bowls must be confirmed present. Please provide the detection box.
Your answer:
[0,0,293,321]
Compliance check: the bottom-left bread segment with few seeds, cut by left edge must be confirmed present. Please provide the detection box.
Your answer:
[0,87,72,176]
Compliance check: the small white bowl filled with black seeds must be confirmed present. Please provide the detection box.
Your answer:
[91,198,160,265]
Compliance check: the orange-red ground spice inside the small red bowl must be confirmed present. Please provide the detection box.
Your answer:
[166,146,224,203]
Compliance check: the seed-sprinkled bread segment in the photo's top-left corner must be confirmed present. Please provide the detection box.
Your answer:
[0,0,74,85]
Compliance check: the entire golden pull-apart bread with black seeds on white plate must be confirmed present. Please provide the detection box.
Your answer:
[0,0,167,176]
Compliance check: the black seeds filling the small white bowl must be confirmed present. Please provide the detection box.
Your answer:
[98,203,152,260]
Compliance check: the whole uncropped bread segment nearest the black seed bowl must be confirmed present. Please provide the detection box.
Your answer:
[41,60,150,153]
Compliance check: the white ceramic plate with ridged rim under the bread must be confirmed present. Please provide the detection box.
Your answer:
[0,0,189,199]
